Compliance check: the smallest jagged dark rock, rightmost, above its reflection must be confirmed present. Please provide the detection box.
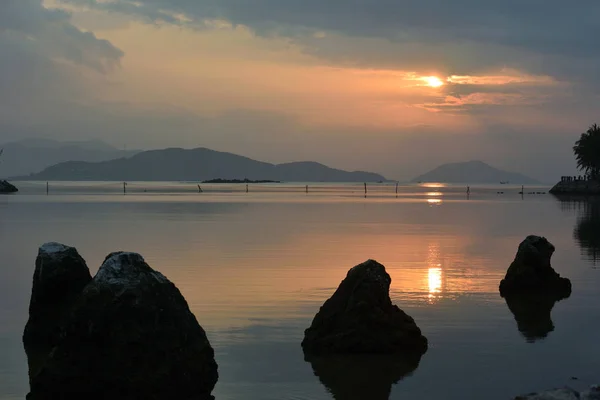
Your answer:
[500,235,571,297]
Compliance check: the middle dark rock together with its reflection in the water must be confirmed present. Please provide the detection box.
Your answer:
[301,260,428,400]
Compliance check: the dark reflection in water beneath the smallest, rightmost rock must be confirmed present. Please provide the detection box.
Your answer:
[505,292,569,343]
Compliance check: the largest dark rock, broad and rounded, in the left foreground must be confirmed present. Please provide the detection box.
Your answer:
[27,252,218,400]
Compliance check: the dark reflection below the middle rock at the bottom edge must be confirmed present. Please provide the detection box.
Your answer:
[305,354,421,400]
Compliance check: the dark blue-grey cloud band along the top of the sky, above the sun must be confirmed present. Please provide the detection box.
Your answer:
[61,0,600,79]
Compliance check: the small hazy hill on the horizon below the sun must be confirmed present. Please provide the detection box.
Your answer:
[412,161,539,184]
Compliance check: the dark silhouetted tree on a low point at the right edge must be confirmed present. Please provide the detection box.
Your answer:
[550,124,600,195]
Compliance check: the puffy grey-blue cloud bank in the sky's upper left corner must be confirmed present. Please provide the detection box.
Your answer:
[0,0,123,136]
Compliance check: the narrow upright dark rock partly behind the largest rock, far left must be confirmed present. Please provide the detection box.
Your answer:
[23,243,92,375]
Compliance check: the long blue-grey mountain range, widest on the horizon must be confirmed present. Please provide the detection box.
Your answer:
[12,148,386,182]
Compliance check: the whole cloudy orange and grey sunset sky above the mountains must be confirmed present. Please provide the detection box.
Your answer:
[0,0,600,182]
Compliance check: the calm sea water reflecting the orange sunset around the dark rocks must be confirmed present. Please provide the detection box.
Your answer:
[0,182,600,400]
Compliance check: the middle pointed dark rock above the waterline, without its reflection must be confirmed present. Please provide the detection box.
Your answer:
[302,260,427,355]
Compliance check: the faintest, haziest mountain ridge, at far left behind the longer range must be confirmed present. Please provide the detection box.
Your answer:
[0,139,139,177]
